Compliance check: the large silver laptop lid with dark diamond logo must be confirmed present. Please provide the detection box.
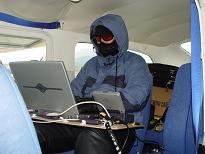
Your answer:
[9,61,78,116]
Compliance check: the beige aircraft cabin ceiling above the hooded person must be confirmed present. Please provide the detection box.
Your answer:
[0,0,190,46]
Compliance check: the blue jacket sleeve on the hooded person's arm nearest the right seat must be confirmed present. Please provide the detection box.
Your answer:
[120,56,152,112]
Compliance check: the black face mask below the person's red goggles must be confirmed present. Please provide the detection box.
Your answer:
[96,41,119,57]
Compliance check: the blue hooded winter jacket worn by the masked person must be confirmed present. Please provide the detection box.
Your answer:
[71,14,152,152]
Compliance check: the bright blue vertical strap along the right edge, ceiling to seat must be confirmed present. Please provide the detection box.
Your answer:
[191,0,203,146]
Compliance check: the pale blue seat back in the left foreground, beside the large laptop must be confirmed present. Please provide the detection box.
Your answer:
[0,65,41,154]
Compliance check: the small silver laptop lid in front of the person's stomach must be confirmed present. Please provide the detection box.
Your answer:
[93,91,125,113]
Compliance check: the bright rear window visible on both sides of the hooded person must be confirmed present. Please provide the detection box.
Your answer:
[75,43,153,76]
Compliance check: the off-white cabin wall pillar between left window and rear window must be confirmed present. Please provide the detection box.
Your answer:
[45,30,89,79]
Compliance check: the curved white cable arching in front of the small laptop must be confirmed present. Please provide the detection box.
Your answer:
[46,101,111,118]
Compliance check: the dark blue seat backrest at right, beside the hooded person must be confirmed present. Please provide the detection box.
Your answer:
[163,64,196,154]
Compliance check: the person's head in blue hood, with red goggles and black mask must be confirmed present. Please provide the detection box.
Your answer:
[90,14,128,57]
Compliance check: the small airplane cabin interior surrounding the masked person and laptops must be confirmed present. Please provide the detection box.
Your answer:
[0,0,205,154]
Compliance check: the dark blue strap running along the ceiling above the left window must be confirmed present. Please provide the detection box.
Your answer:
[0,12,60,29]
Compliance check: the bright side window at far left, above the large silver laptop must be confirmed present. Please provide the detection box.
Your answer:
[0,34,46,69]
